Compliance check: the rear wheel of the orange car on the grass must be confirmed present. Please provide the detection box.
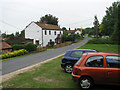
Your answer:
[79,77,93,89]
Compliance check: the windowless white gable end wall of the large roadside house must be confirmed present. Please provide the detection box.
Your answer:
[25,22,42,44]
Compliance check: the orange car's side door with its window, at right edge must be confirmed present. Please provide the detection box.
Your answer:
[106,56,120,84]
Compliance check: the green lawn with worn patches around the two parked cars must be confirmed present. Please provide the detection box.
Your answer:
[2,44,118,90]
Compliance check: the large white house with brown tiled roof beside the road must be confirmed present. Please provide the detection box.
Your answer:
[25,22,63,46]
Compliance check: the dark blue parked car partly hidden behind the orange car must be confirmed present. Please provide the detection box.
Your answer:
[61,49,97,73]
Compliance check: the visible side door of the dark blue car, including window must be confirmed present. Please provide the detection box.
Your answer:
[69,51,83,65]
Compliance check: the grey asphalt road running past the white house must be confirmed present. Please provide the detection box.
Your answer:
[2,37,90,75]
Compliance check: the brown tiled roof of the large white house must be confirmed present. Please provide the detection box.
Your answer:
[35,22,62,30]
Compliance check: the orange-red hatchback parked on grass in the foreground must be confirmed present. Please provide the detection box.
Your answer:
[72,52,120,89]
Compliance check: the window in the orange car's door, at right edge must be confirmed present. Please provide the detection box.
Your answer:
[106,56,120,68]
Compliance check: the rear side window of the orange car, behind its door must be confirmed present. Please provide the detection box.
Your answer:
[85,56,104,67]
